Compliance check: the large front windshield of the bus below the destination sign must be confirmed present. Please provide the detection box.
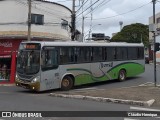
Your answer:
[17,50,40,74]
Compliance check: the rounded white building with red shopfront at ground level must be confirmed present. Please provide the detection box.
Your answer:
[0,0,71,83]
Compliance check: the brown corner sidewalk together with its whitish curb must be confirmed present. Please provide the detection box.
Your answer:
[50,83,160,108]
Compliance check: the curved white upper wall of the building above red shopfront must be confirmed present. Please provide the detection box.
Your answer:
[0,0,71,40]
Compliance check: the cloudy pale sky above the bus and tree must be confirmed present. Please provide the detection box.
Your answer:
[49,0,160,37]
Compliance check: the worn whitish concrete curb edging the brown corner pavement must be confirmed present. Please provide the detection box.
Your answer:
[49,93,155,107]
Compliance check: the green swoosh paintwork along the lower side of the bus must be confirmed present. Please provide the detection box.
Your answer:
[67,62,144,85]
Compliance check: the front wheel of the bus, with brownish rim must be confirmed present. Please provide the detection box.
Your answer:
[61,76,73,90]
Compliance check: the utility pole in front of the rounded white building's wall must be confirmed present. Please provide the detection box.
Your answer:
[28,0,31,41]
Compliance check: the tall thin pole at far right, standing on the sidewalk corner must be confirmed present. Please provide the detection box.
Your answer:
[152,0,157,87]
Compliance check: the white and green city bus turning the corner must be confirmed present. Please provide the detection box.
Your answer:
[15,41,145,91]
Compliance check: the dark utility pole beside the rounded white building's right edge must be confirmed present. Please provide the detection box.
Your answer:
[71,0,76,41]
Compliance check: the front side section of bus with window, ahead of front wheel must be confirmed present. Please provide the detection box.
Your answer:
[40,47,60,90]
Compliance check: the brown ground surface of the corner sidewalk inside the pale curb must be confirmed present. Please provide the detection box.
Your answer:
[54,86,160,107]
